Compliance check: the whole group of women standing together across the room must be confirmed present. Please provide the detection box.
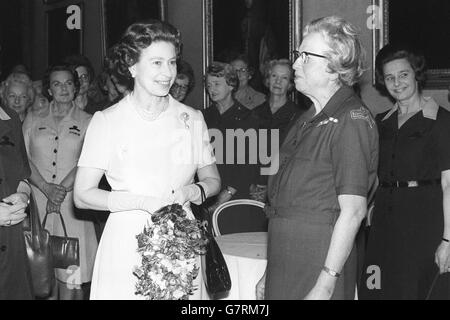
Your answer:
[0,16,450,300]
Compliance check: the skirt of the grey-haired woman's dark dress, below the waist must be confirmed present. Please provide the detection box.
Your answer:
[265,218,356,300]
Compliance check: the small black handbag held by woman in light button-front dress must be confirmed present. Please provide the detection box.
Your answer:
[43,212,80,269]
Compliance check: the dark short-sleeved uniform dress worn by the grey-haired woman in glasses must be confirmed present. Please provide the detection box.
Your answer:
[265,86,378,299]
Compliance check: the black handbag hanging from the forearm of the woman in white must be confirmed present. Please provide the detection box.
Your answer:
[197,184,231,299]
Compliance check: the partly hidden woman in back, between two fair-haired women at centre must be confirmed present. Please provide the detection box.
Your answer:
[231,56,266,110]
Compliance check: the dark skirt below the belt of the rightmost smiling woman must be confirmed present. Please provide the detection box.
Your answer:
[359,186,450,300]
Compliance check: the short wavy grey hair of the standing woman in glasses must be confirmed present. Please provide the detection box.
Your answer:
[303,16,366,86]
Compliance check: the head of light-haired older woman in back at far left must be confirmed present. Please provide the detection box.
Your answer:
[0,73,34,122]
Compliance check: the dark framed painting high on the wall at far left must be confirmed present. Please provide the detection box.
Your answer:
[46,3,83,65]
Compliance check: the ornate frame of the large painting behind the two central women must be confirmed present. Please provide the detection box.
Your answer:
[202,0,302,107]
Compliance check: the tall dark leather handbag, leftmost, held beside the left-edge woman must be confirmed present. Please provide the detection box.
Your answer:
[23,192,55,298]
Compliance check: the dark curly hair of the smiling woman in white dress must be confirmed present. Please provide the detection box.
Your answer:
[106,20,181,86]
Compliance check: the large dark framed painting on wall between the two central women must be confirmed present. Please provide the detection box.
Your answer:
[202,0,302,107]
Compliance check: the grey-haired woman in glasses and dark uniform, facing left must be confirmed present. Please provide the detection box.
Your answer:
[256,16,378,299]
